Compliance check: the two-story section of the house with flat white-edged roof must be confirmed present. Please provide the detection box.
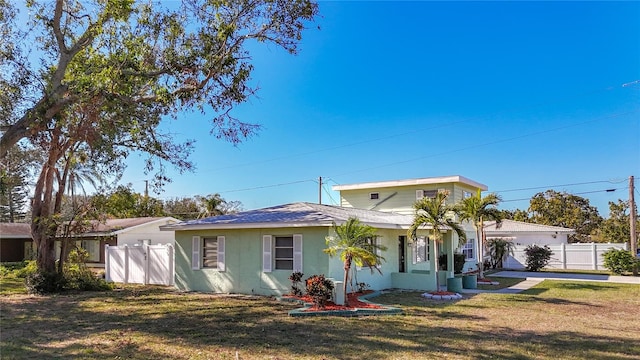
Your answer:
[333,175,488,271]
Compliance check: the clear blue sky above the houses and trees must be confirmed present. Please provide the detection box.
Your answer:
[123,1,640,216]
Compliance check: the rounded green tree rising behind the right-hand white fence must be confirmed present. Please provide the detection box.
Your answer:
[529,190,602,242]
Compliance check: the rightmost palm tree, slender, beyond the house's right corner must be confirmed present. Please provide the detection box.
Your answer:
[457,190,502,279]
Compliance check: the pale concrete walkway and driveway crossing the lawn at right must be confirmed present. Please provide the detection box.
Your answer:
[462,271,640,294]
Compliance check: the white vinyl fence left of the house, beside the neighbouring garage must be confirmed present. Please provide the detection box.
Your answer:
[105,244,174,285]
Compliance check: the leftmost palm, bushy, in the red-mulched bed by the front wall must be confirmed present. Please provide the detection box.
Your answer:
[323,217,387,305]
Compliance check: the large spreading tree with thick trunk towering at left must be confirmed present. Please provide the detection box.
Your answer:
[0,0,318,272]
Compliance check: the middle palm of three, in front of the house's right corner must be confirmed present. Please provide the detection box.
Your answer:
[407,192,467,290]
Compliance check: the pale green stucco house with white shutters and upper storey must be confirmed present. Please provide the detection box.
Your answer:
[161,176,486,295]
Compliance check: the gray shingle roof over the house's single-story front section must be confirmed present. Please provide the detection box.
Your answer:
[161,202,413,230]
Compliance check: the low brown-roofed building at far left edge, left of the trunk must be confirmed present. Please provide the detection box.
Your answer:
[0,223,34,262]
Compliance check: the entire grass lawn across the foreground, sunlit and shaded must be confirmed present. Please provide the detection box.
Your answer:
[0,281,640,360]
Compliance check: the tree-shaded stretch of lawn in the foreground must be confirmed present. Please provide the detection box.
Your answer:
[0,291,640,359]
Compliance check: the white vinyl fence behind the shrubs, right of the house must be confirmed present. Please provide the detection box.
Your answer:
[503,243,629,270]
